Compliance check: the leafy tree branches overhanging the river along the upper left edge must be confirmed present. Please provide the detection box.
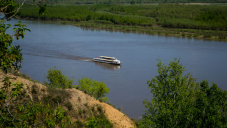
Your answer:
[0,0,46,73]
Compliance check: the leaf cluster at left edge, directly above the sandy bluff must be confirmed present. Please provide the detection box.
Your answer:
[0,21,30,73]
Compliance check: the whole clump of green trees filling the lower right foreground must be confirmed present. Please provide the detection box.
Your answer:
[139,59,227,127]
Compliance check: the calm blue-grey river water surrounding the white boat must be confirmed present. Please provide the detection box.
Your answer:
[9,19,227,118]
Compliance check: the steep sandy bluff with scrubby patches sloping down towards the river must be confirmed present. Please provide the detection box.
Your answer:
[0,71,136,128]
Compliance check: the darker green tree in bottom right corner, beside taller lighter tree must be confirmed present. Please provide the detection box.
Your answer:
[191,80,227,128]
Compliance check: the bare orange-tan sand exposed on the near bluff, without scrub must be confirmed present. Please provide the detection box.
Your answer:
[0,71,135,128]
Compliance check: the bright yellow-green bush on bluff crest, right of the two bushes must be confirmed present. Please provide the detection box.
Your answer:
[77,77,110,102]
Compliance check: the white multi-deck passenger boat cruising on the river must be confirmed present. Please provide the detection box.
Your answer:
[93,56,121,65]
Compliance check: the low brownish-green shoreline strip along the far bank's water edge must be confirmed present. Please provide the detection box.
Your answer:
[17,17,227,42]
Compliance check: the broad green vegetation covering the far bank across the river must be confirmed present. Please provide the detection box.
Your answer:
[18,4,227,41]
